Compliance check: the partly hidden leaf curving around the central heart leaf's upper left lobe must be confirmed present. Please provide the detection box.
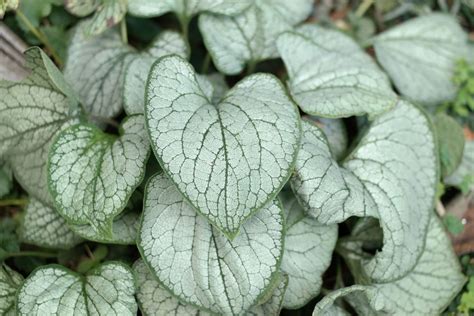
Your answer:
[123,31,189,115]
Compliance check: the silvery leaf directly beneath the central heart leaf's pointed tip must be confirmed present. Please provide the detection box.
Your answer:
[138,174,283,315]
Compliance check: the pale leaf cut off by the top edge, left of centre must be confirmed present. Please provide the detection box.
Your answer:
[128,0,251,21]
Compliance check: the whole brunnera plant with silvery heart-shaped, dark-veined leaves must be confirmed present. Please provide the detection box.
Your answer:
[0,0,470,315]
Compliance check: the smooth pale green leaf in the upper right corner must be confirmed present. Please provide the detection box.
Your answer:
[374,13,469,105]
